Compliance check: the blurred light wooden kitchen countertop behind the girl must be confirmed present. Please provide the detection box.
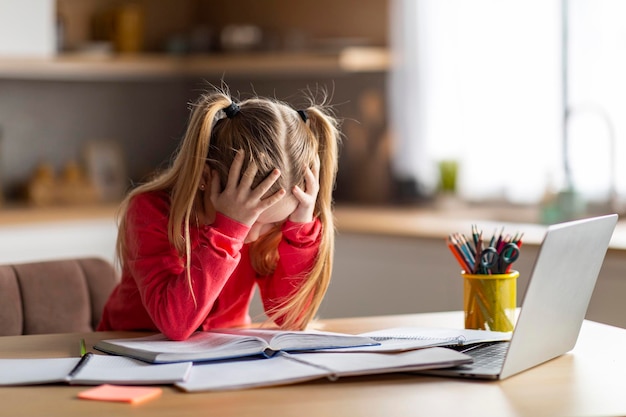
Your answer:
[0,203,626,250]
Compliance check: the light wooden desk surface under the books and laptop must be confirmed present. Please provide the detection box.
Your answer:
[0,312,626,417]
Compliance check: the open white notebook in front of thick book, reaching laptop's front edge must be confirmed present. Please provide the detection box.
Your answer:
[175,347,472,392]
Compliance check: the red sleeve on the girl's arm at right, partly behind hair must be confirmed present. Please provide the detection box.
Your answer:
[259,218,322,311]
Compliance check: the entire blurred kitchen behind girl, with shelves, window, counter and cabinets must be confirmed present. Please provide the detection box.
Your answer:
[0,0,626,325]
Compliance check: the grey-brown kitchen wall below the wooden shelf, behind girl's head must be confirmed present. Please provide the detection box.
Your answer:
[0,73,388,201]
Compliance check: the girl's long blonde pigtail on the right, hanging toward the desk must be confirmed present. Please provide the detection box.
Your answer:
[270,101,340,329]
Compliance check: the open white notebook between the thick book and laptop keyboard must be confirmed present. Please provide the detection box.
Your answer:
[330,327,512,352]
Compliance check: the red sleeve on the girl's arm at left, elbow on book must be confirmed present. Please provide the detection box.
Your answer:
[125,196,249,340]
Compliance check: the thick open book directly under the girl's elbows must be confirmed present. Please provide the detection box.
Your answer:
[94,329,378,363]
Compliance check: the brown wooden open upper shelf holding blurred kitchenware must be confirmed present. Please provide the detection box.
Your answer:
[0,0,389,80]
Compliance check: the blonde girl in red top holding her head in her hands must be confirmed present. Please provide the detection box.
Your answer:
[98,86,340,340]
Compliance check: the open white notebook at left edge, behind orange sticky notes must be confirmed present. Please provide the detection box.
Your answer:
[0,353,192,386]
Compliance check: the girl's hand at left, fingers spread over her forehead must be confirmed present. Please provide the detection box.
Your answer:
[211,150,285,226]
